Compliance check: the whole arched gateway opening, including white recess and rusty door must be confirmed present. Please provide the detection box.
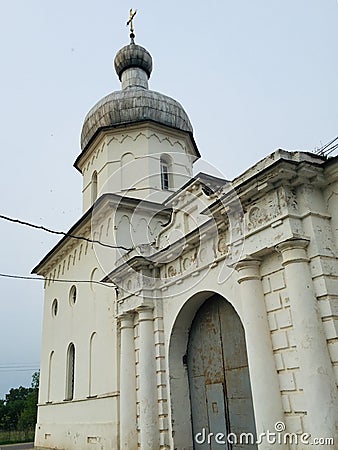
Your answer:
[169,291,257,450]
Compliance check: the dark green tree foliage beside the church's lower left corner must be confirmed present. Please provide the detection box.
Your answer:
[0,372,39,440]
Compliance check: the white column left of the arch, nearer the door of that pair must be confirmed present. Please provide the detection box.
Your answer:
[138,308,159,450]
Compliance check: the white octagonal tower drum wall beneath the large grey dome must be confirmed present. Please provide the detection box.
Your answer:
[81,124,196,212]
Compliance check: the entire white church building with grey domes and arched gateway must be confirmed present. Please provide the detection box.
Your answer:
[34,30,338,450]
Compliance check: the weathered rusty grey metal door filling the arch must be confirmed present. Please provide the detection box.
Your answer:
[187,295,257,450]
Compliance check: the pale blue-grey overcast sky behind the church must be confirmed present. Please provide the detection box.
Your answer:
[0,0,338,398]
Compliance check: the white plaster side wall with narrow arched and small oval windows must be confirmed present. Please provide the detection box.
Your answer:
[36,230,119,450]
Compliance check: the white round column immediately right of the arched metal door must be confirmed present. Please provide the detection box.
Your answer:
[236,258,288,450]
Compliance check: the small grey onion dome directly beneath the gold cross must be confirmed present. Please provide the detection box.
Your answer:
[114,44,153,81]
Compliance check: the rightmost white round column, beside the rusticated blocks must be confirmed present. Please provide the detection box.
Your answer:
[277,239,338,442]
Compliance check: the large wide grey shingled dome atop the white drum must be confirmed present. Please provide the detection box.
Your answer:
[81,88,193,150]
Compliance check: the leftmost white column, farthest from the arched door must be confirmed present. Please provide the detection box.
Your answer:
[120,314,137,450]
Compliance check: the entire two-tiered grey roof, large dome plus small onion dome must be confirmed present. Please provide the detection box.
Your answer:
[81,43,193,150]
